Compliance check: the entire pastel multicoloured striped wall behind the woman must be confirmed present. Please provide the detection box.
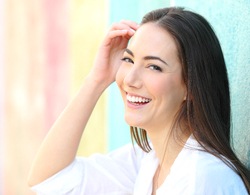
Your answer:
[0,0,250,195]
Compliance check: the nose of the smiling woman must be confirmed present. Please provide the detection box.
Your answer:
[123,65,142,88]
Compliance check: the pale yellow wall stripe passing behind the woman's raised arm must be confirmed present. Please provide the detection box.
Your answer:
[69,0,108,156]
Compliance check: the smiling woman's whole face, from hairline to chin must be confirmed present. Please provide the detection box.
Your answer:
[116,23,186,133]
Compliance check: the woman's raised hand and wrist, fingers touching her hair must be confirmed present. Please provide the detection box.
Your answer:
[88,20,138,89]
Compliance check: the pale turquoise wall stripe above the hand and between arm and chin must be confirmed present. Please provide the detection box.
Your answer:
[108,0,169,150]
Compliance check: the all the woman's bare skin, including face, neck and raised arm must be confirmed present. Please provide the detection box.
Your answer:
[28,21,189,193]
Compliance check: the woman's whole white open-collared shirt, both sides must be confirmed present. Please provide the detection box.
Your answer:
[32,137,247,195]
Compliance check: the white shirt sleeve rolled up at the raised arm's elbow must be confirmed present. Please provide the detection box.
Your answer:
[31,144,144,195]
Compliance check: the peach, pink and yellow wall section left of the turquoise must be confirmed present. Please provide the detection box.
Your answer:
[0,0,108,195]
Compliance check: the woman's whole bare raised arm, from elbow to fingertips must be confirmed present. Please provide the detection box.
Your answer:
[28,21,137,186]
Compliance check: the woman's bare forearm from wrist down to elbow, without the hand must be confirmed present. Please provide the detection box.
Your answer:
[29,78,105,186]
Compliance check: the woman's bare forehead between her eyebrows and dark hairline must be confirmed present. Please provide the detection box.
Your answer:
[128,23,177,56]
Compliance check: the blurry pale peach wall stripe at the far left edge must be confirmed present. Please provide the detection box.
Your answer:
[3,0,49,195]
